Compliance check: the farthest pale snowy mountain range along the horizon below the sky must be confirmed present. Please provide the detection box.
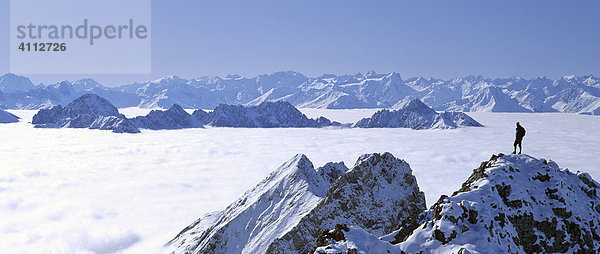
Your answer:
[0,71,600,115]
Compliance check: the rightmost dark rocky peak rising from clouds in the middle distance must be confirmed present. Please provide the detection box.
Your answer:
[354,99,483,130]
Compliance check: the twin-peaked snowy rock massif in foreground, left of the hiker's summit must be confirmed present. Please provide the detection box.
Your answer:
[168,153,425,253]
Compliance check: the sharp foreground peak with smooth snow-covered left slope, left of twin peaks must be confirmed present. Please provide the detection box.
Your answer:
[168,154,347,253]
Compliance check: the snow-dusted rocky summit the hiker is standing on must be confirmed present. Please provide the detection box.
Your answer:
[317,154,600,253]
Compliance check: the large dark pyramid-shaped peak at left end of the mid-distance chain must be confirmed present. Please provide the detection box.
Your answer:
[31,94,140,133]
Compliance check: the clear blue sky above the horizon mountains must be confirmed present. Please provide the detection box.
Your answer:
[0,0,600,86]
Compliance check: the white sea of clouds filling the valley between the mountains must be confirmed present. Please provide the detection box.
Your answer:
[0,109,600,253]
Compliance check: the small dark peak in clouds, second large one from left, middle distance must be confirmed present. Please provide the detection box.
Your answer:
[130,104,204,130]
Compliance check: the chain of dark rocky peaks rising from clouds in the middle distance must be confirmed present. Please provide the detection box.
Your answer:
[28,94,483,133]
